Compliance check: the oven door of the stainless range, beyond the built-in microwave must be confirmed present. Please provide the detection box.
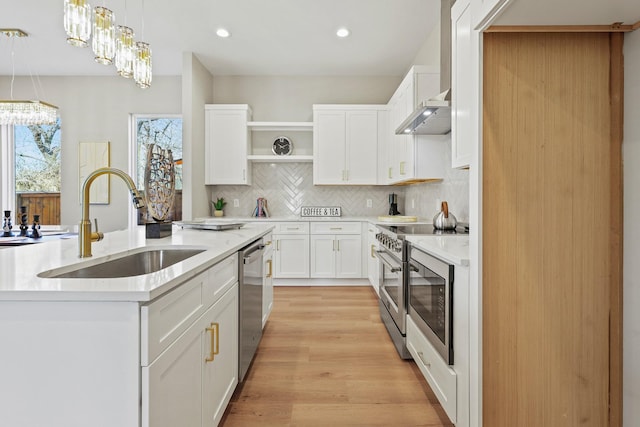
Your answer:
[376,248,407,335]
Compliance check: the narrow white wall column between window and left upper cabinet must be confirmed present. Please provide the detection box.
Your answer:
[182,52,213,220]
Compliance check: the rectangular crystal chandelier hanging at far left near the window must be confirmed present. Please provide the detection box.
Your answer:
[0,28,58,125]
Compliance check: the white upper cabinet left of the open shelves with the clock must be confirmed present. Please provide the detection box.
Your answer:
[205,104,251,185]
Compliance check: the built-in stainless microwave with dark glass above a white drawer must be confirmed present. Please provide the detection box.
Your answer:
[409,246,454,365]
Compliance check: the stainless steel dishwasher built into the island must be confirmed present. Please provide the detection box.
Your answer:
[238,239,264,382]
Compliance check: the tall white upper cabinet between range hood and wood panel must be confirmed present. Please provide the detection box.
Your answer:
[451,0,478,168]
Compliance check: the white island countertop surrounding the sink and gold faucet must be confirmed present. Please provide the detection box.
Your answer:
[0,223,273,301]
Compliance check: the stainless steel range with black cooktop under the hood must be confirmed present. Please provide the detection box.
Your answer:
[376,224,469,359]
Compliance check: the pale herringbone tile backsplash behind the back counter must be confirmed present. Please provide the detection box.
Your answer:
[210,158,469,222]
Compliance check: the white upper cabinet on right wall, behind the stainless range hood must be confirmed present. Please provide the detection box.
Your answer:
[381,65,449,184]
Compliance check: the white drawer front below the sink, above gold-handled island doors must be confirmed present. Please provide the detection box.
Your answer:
[140,271,209,366]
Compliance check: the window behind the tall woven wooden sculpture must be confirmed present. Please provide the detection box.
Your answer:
[132,115,182,224]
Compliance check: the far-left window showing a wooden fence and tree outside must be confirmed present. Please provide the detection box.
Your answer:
[0,119,61,225]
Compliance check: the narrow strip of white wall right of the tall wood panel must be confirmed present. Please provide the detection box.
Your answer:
[623,31,640,427]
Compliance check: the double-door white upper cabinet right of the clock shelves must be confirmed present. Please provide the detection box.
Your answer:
[313,105,386,185]
